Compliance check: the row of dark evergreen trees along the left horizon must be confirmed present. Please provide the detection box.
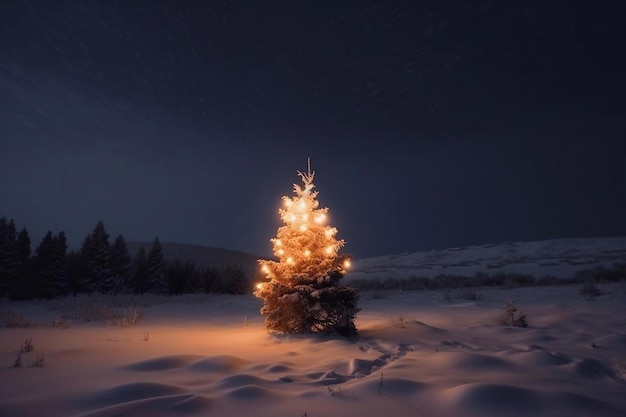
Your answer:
[0,217,251,300]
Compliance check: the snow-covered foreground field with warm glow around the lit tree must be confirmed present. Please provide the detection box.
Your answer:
[0,282,626,417]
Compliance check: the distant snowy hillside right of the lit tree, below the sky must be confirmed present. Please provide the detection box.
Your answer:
[346,237,626,282]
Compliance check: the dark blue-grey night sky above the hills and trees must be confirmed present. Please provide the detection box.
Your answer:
[0,0,626,258]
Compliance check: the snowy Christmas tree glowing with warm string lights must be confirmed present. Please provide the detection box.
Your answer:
[254,161,359,336]
